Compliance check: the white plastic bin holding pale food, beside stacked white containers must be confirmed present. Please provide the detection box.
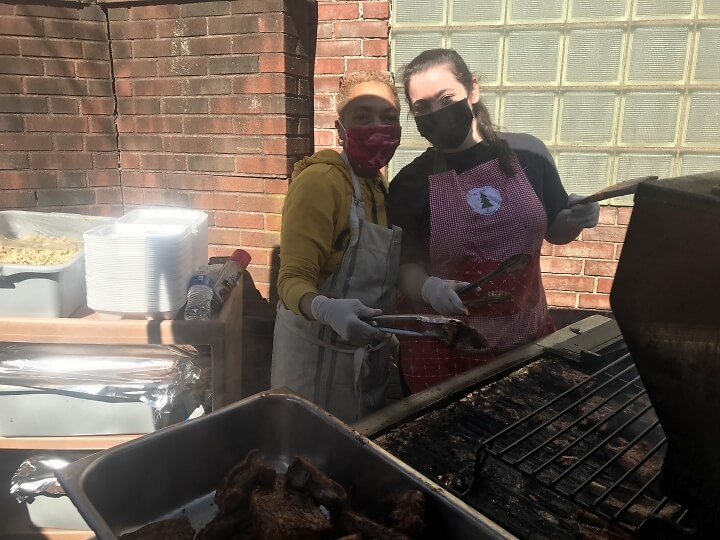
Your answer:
[0,210,114,317]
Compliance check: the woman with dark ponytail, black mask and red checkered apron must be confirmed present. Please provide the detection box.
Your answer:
[390,49,599,392]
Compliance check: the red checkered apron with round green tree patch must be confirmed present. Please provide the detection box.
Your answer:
[398,152,554,393]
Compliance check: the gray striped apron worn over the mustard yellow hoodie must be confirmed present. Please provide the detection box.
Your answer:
[270,153,402,423]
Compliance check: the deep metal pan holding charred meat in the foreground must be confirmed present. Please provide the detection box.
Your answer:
[57,392,512,540]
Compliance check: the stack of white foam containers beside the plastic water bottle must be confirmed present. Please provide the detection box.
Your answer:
[84,222,193,315]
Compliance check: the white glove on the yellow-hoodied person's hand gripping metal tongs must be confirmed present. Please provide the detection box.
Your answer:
[310,295,385,346]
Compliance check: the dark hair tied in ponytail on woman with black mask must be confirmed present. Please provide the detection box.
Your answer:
[402,49,515,176]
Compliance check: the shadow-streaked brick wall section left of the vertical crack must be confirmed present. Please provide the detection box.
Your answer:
[0,3,122,215]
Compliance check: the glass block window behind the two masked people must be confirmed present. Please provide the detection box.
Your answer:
[390,0,720,205]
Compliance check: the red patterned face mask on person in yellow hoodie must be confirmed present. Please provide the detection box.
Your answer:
[338,122,400,173]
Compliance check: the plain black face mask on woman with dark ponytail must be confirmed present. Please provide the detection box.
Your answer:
[415,99,474,150]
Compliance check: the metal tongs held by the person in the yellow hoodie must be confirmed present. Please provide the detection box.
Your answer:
[363,314,488,349]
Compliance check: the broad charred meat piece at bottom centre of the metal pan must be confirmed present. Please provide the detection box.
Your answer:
[250,474,332,540]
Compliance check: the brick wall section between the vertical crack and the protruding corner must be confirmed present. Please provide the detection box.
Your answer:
[108,0,314,296]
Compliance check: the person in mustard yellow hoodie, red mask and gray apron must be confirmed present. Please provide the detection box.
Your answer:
[271,72,401,422]
